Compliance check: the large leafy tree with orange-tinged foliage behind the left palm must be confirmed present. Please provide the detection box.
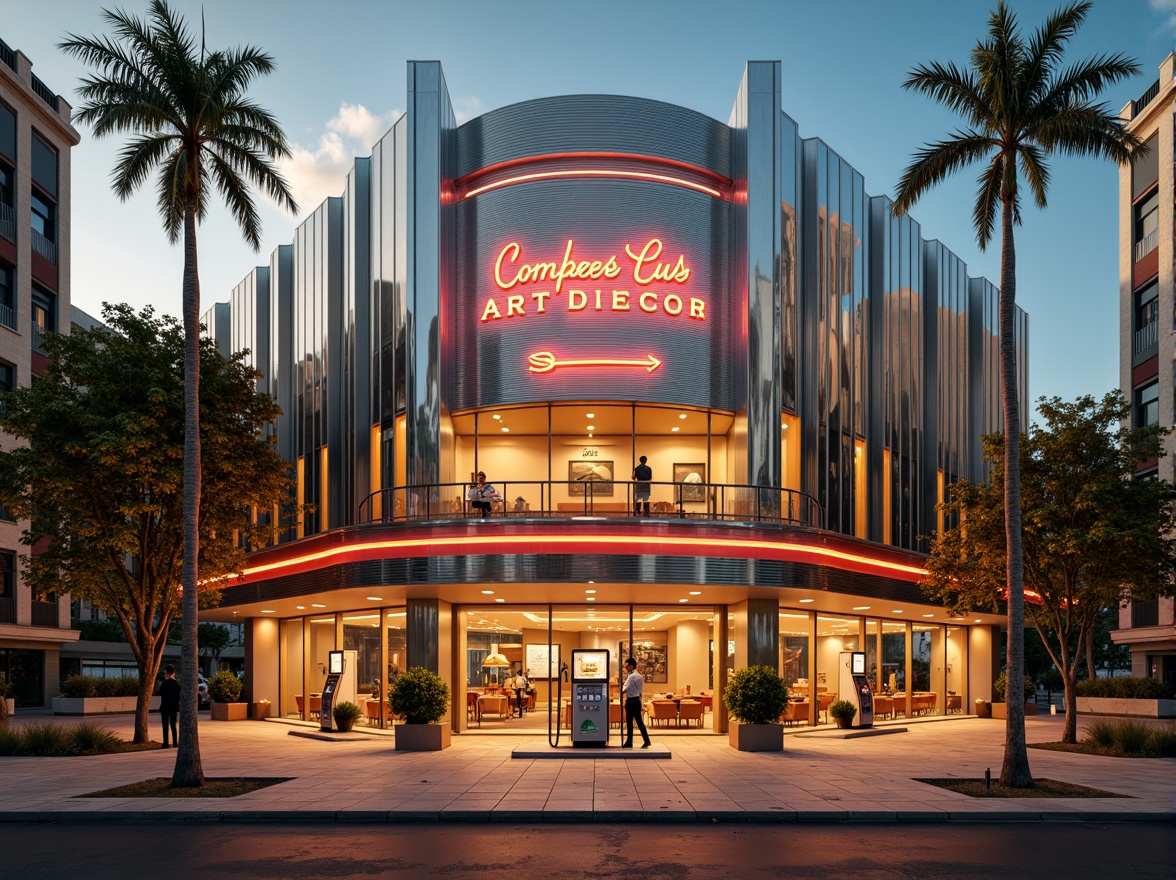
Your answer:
[0,306,290,742]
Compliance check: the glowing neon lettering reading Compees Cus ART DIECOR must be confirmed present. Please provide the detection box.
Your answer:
[481,238,707,324]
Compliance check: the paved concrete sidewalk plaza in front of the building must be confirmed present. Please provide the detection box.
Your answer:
[0,715,1176,822]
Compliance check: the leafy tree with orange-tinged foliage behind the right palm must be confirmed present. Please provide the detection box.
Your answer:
[923,392,1176,742]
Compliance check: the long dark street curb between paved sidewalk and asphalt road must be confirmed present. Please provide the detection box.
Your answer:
[0,809,1176,825]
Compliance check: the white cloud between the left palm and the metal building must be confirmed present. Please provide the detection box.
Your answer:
[278,101,401,216]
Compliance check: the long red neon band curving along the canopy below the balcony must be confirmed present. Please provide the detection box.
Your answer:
[231,534,927,581]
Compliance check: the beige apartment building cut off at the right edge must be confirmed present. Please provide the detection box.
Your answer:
[1111,55,1176,685]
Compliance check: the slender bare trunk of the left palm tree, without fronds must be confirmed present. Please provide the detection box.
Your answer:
[172,199,205,788]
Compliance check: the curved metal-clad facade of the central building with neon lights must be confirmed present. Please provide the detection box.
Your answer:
[209,62,1028,729]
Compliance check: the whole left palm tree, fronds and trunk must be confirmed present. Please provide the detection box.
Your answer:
[60,0,298,787]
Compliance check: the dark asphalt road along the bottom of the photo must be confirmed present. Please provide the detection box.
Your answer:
[0,822,1176,880]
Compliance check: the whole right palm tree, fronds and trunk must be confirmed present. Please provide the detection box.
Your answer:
[894,0,1141,788]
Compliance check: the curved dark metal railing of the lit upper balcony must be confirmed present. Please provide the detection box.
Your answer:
[359,480,824,528]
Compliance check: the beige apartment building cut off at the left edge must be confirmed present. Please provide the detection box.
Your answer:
[0,40,79,707]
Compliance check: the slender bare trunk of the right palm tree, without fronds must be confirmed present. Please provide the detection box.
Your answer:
[1001,193,1033,788]
